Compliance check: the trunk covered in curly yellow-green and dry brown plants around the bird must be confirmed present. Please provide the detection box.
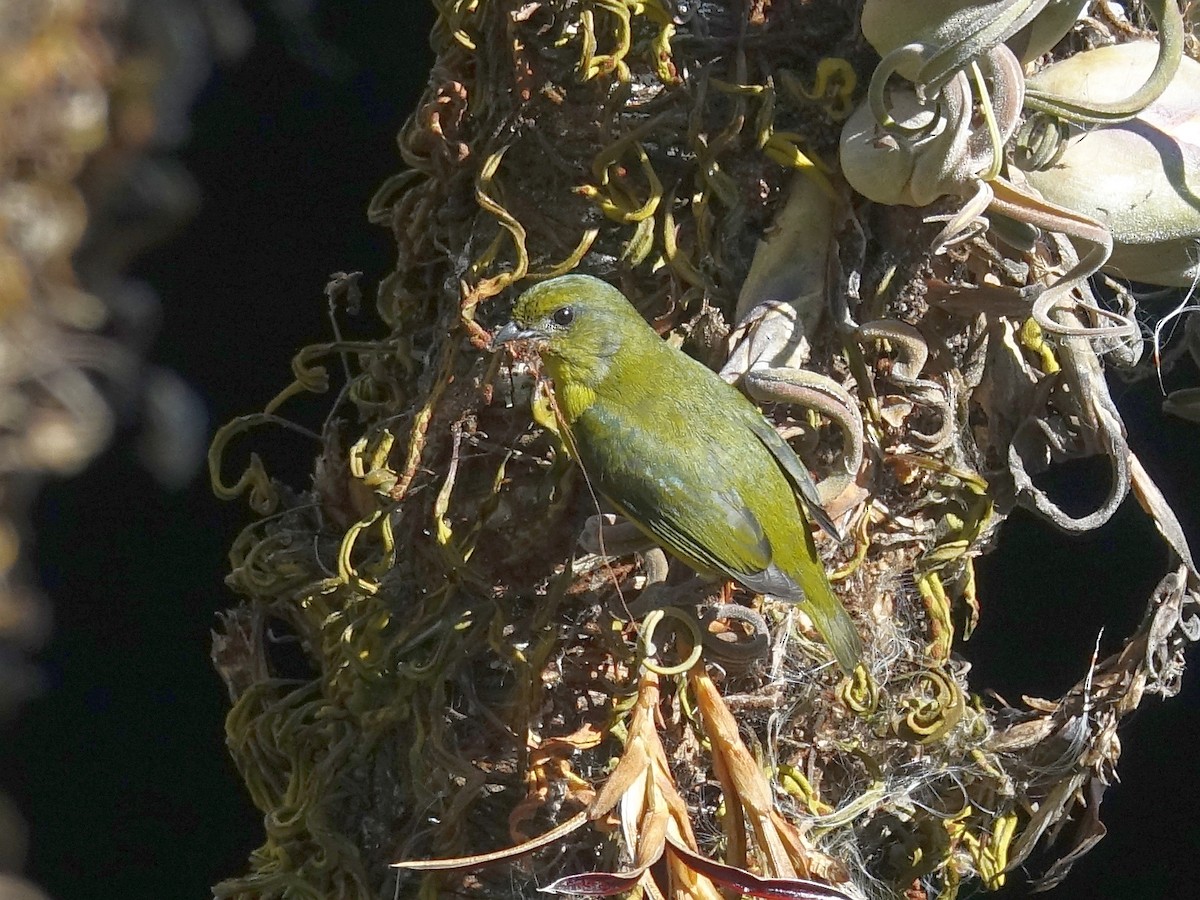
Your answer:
[212,0,1198,900]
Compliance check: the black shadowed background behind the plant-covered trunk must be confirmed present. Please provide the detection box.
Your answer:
[0,1,1200,900]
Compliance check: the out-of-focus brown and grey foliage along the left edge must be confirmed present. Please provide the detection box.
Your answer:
[0,0,250,896]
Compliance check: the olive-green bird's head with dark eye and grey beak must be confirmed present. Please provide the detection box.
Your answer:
[492,275,658,371]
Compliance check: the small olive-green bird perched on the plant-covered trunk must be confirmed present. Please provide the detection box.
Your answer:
[492,275,862,673]
